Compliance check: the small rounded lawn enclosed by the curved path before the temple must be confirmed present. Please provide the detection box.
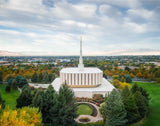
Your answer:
[77,104,92,115]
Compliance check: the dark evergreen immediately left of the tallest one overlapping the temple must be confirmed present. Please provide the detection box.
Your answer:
[40,85,58,123]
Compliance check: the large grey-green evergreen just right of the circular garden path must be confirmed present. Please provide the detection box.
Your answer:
[106,89,127,126]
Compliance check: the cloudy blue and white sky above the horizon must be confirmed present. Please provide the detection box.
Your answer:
[0,0,160,56]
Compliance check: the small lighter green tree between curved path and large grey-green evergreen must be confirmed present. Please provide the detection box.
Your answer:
[99,103,107,125]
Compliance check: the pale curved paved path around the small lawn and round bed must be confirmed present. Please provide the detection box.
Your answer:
[75,102,103,124]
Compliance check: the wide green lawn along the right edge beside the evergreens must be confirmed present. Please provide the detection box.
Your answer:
[132,82,160,126]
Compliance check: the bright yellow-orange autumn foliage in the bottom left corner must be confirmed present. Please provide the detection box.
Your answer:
[0,107,42,126]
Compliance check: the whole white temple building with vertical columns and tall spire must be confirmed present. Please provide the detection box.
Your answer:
[52,37,115,98]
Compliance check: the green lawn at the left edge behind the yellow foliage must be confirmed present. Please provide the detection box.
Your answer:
[0,84,20,108]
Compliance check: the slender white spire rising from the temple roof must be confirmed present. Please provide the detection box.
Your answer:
[78,36,84,71]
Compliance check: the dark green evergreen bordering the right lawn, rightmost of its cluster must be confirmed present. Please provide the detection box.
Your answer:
[134,91,148,118]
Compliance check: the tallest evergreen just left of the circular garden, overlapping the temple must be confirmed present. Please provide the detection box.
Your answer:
[51,84,78,126]
